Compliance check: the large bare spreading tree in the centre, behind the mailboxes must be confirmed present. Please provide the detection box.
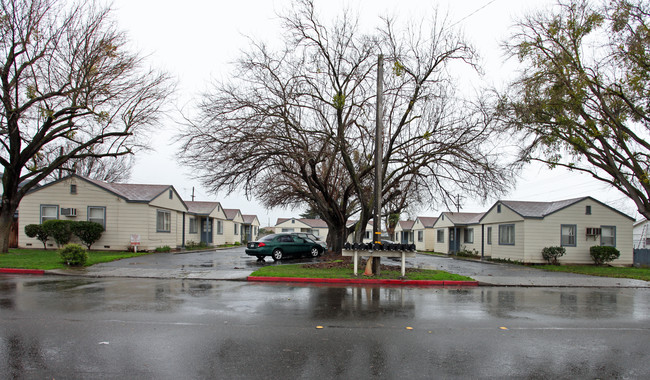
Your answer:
[181,0,509,255]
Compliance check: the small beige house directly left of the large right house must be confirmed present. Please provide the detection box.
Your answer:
[433,212,484,254]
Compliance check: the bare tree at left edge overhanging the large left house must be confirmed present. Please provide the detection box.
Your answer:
[0,0,173,252]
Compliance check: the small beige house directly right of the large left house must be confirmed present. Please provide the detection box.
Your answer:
[185,201,227,245]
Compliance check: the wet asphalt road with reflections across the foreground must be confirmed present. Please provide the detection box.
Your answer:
[0,275,650,379]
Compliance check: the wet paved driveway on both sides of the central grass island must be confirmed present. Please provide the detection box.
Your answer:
[48,247,650,288]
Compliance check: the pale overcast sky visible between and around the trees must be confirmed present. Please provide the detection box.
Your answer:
[107,0,639,226]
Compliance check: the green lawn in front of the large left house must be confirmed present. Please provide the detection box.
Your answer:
[0,249,156,270]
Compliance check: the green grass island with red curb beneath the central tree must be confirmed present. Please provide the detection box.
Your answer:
[251,264,474,281]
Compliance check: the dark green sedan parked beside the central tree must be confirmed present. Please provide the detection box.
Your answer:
[246,234,323,261]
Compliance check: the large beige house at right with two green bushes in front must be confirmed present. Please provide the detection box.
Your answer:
[480,197,634,265]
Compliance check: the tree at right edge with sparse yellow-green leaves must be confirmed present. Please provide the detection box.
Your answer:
[499,0,650,218]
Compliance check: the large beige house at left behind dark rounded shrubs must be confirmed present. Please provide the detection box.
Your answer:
[18,175,188,250]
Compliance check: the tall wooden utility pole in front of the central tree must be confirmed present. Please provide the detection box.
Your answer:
[372,54,384,276]
